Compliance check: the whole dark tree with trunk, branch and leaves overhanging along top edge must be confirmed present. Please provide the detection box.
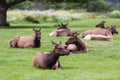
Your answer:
[0,0,96,26]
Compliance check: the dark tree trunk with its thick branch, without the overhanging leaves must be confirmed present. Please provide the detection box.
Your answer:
[0,0,26,26]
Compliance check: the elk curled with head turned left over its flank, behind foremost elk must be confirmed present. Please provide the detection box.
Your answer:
[65,33,88,53]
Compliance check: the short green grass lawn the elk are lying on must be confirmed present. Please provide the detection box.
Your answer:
[0,19,120,80]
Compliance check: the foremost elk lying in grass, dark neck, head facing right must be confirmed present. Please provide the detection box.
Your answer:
[33,41,69,69]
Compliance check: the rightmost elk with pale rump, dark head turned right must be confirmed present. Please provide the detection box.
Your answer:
[82,26,118,41]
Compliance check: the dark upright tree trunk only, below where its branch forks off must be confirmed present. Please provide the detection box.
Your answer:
[0,6,9,26]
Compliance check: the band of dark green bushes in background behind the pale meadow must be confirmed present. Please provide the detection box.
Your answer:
[5,0,120,12]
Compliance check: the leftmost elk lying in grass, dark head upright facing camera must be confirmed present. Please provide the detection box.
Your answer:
[9,28,41,48]
